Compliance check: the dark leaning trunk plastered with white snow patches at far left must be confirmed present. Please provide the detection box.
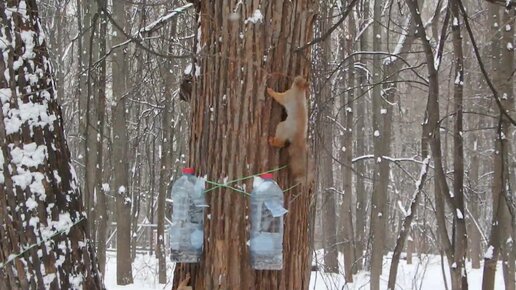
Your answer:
[0,0,103,290]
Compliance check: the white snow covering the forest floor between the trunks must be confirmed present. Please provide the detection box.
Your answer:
[105,252,504,290]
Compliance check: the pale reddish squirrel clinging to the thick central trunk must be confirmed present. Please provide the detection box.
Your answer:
[267,76,311,184]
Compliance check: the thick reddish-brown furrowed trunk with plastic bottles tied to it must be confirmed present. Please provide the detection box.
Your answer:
[174,0,316,290]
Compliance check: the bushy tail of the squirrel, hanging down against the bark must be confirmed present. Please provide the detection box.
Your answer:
[288,138,313,185]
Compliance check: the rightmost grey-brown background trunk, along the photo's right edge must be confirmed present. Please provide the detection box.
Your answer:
[482,6,515,290]
